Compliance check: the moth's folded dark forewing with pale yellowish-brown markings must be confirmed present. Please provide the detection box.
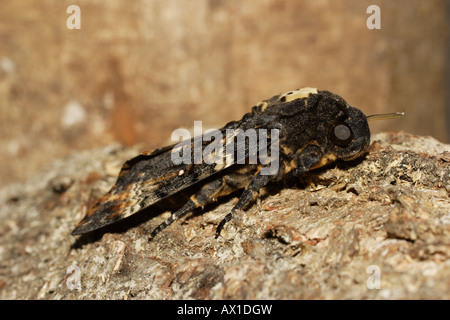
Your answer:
[72,107,284,235]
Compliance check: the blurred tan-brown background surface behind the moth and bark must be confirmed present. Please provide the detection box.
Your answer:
[0,0,450,187]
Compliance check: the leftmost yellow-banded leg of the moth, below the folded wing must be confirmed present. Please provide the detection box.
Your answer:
[150,172,251,239]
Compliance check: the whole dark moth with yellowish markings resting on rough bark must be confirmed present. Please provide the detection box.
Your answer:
[72,88,403,238]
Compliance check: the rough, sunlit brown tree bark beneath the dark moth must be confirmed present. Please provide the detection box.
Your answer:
[0,133,450,299]
